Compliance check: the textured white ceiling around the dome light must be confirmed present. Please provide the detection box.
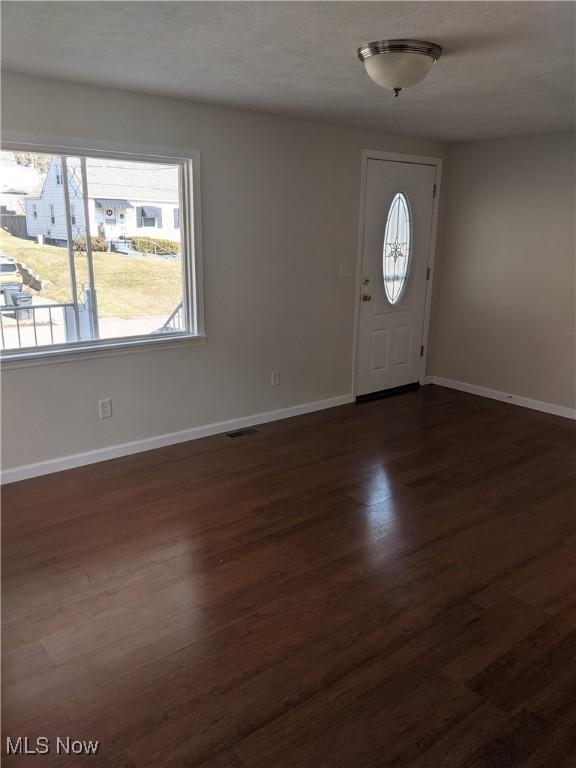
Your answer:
[2,0,575,140]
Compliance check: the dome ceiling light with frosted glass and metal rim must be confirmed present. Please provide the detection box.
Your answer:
[358,40,442,96]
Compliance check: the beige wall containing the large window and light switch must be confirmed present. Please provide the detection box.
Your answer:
[2,74,442,467]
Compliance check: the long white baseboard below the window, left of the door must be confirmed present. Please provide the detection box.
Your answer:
[2,394,355,485]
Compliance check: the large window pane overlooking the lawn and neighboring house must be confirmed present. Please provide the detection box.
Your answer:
[0,148,201,358]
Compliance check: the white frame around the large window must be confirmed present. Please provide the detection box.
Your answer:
[0,140,206,369]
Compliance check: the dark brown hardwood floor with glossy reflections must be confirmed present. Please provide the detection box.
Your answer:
[3,386,576,768]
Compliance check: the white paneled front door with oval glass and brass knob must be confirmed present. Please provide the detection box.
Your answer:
[356,158,436,395]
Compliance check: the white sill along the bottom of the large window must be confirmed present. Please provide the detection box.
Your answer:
[0,334,206,371]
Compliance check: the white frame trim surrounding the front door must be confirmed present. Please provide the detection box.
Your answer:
[352,149,442,397]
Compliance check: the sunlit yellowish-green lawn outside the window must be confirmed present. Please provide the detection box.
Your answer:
[0,229,182,318]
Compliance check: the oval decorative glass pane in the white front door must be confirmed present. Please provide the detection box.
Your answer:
[382,192,412,304]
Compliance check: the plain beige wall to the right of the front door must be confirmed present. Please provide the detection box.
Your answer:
[429,135,576,408]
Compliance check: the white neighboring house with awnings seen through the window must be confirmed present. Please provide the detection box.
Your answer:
[25,155,180,245]
